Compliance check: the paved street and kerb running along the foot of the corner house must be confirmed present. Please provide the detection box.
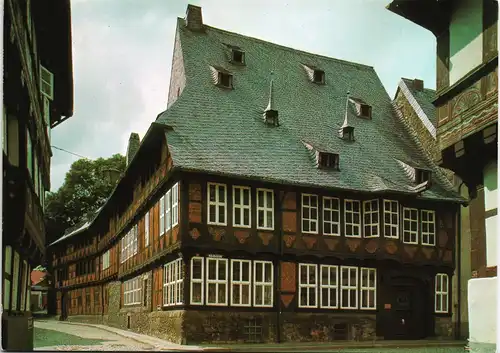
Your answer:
[34,320,465,353]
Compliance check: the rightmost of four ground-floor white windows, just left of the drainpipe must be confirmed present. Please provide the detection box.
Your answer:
[253,260,274,307]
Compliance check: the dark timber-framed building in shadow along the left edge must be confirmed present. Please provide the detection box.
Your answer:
[2,0,73,350]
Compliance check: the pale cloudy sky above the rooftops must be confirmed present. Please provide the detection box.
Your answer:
[50,0,436,191]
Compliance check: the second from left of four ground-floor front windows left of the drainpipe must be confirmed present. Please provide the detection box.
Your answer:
[206,257,228,305]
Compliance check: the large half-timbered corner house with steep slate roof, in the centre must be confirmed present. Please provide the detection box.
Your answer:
[50,5,464,344]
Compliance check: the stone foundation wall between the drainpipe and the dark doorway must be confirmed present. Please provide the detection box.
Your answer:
[282,313,376,342]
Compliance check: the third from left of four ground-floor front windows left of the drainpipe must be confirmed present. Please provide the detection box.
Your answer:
[231,260,252,306]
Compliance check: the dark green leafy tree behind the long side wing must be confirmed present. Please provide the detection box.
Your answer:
[45,154,126,243]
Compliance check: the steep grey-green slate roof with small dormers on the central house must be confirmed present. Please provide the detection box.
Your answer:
[157,18,464,202]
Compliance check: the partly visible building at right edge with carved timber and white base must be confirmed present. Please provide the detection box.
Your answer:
[388,0,498,349]
